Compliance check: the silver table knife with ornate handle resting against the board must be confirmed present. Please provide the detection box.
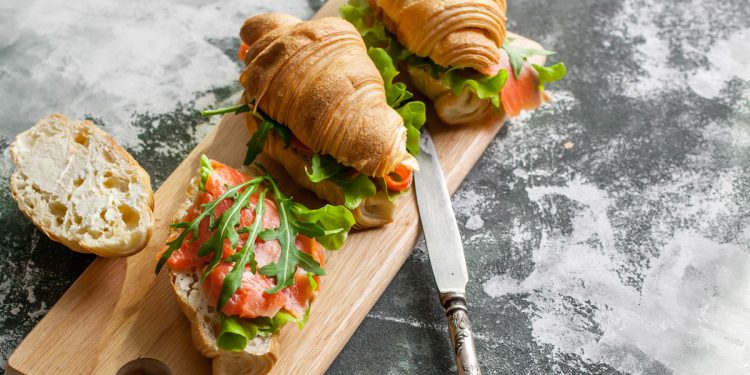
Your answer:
[414,128,481,375]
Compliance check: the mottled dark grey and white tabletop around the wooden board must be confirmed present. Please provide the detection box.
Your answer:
[0,0,750,374]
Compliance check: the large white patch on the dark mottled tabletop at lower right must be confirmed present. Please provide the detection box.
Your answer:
[482,86,750,374]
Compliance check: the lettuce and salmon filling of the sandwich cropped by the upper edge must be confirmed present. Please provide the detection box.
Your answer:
[340,0,566,117]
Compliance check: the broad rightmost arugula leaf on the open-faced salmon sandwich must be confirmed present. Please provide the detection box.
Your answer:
[259,179,325,294]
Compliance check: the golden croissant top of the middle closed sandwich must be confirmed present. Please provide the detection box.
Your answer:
[240,14,416,176]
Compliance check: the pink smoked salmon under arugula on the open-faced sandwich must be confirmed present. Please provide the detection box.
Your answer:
[160,161,325,318]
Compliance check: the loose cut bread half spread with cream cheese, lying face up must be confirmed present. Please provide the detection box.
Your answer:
[10,114,154,257]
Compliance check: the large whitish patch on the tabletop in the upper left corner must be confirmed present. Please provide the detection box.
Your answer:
[0,0,311,146]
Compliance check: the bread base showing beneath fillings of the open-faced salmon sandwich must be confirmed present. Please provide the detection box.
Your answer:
[169,178,279,375]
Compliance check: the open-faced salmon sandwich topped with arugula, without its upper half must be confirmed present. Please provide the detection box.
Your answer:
[156,155,354,375]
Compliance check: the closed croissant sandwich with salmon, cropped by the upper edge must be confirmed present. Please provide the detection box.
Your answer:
[340,0,565,124]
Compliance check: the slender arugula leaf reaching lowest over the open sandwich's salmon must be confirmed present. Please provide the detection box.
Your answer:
[216,188,266,311]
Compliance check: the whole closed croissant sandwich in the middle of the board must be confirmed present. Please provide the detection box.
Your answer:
[209,14,425,228]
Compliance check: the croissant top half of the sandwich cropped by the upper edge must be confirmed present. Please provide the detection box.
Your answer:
[369,0,506,75]
